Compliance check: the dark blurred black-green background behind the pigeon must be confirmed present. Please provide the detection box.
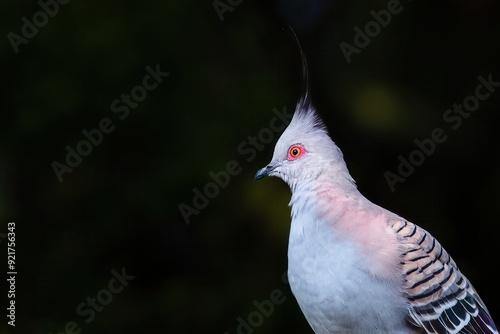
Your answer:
[0,0,500,334]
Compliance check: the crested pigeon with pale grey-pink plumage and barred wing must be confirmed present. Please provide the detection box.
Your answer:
[255,95,498,334]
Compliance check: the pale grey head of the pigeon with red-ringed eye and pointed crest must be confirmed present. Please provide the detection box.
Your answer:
[255,94,352,191]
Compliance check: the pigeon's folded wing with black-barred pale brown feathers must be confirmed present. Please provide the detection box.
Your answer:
[391,220,498,334]
